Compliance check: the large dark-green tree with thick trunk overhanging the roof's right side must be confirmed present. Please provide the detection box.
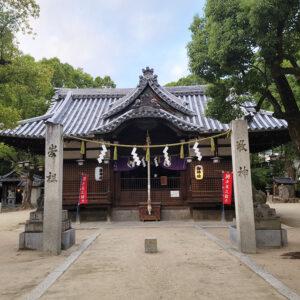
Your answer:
[187,0,300,154]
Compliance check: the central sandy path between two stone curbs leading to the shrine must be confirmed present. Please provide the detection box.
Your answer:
[42,227,284,300]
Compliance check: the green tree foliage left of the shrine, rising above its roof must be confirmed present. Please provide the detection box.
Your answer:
[0,0,116,174]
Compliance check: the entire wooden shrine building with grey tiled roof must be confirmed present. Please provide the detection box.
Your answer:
[0,67,289,220]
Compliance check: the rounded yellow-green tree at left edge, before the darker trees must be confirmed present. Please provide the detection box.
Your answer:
[0,55,53,127]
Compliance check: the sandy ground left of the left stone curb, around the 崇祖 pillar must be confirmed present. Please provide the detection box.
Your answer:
[0,210,95,300]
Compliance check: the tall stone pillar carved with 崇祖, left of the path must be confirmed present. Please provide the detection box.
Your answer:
[43,122,63,255]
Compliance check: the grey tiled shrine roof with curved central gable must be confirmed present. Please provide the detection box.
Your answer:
[0,69,287,138]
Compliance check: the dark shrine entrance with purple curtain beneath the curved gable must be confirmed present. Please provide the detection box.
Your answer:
[109,119,191,207]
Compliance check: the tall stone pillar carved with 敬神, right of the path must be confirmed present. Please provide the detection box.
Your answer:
[231,120,256,253]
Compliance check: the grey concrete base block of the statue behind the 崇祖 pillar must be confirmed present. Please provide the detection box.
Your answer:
[19,228,75,251]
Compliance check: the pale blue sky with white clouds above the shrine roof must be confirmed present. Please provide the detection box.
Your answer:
[18,0,205,88]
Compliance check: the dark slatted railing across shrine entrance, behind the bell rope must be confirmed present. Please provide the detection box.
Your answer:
[121,177,180,191]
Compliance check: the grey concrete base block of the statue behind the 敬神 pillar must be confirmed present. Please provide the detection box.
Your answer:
[229,226,288,248]
